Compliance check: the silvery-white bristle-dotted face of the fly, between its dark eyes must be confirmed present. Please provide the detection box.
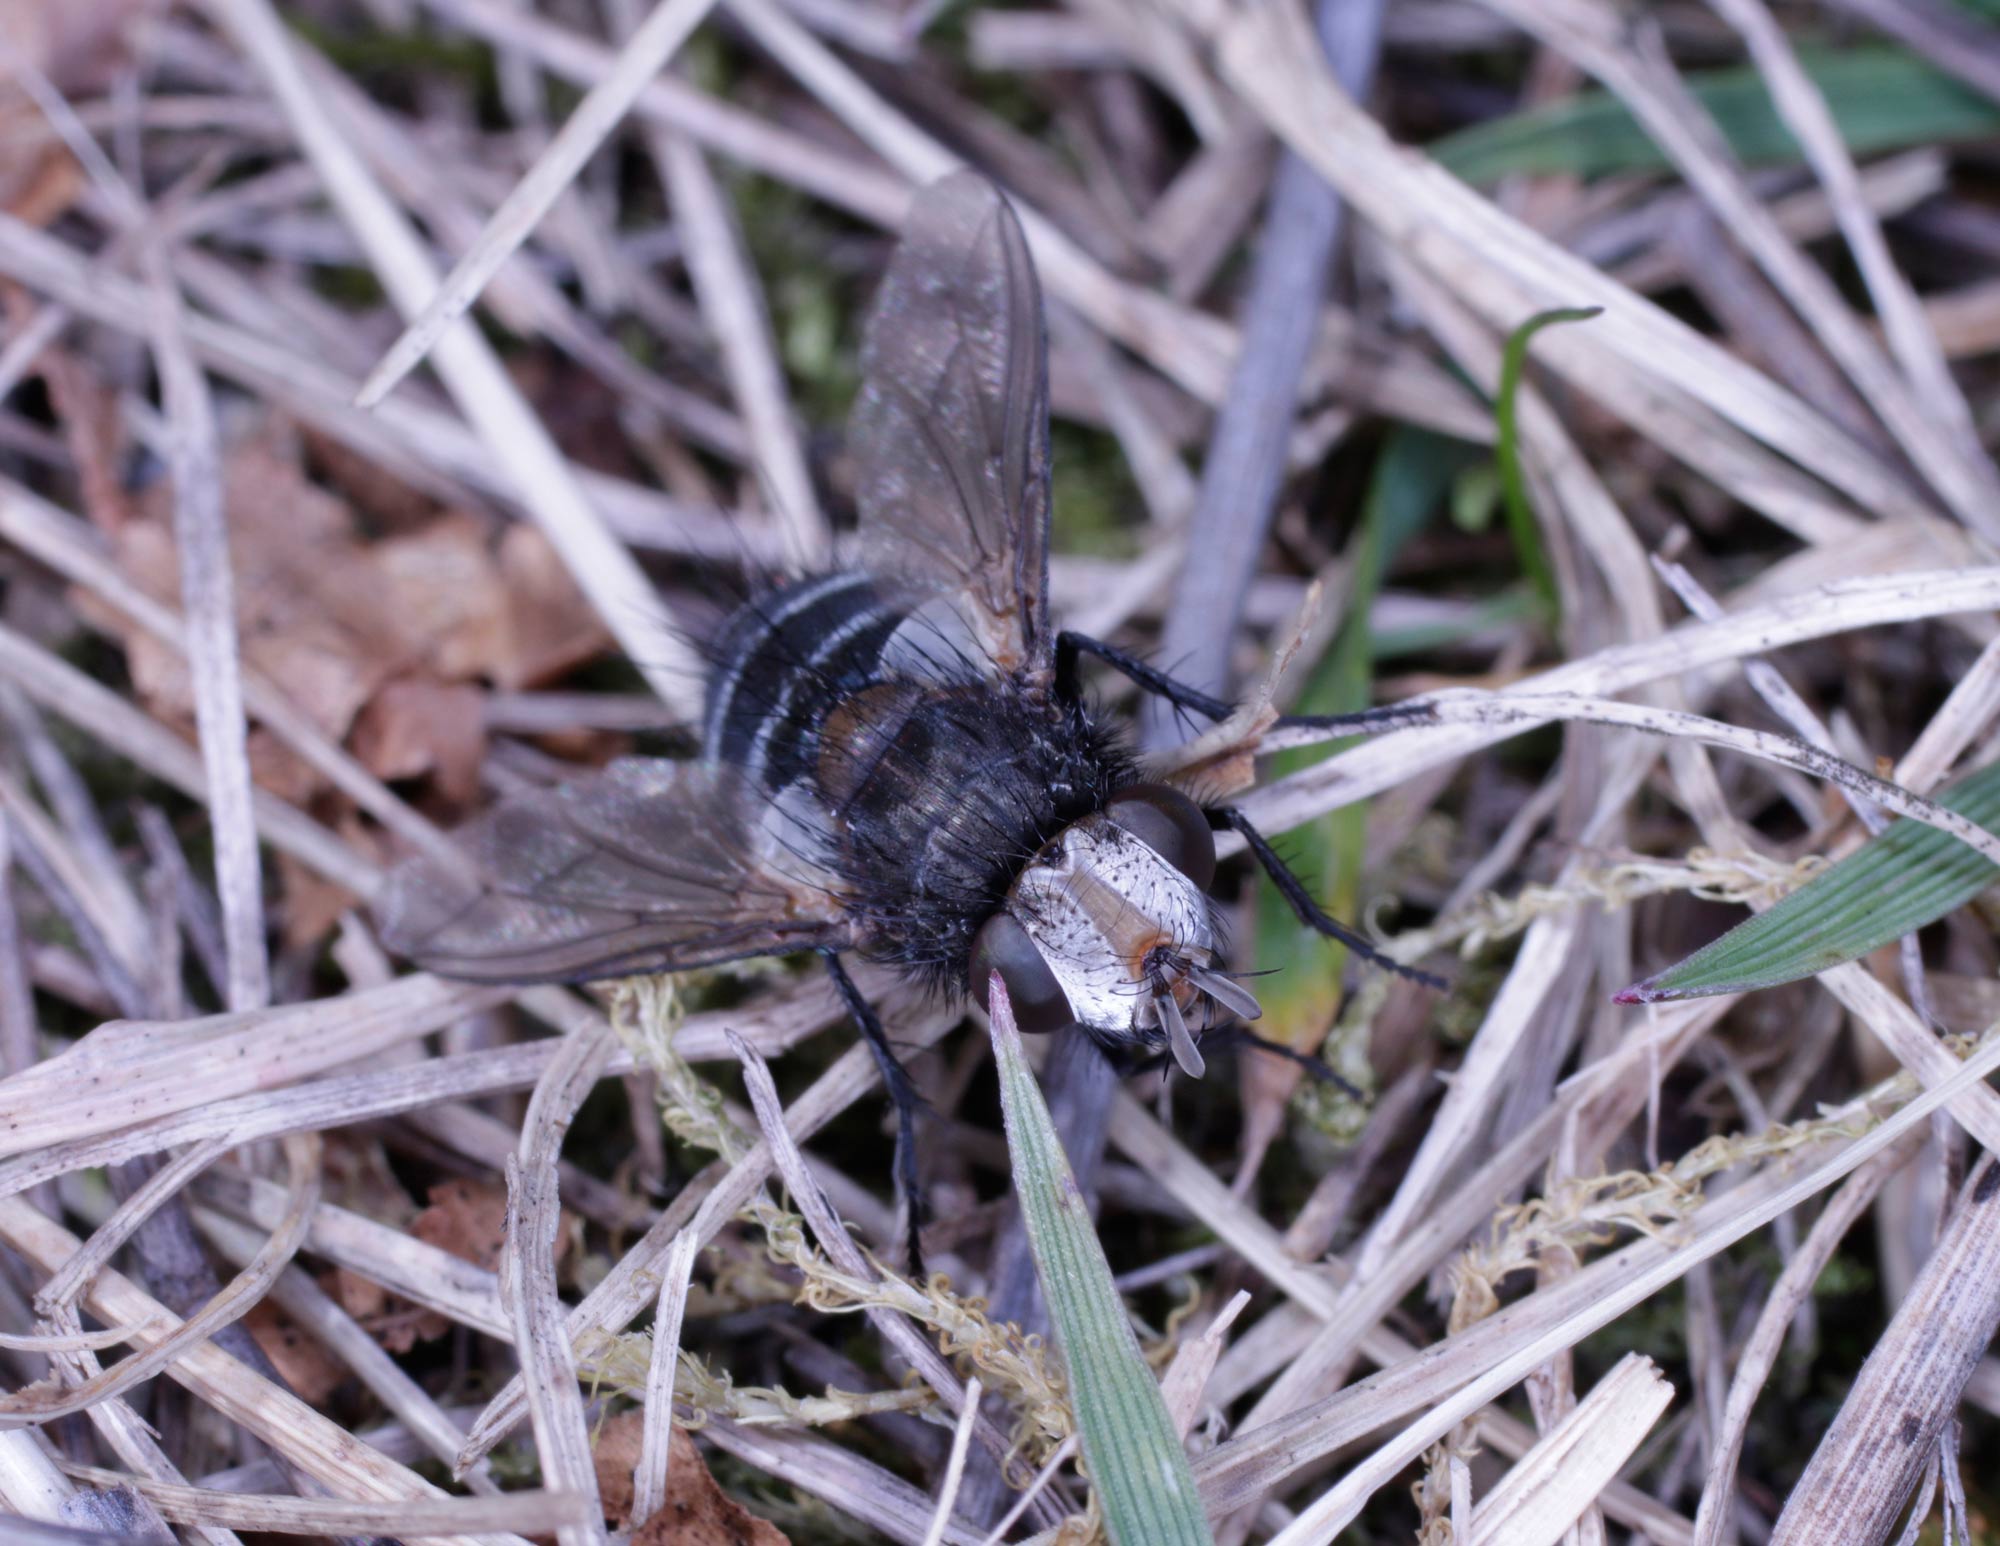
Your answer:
[1008,814,1216,1046]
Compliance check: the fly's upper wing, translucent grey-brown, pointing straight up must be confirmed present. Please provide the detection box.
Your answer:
[852,172,1052,672]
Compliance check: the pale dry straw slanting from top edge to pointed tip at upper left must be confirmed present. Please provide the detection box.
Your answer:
[354,0,714,408]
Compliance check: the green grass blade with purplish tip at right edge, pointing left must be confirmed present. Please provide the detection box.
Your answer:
[1618,762,2000,1004]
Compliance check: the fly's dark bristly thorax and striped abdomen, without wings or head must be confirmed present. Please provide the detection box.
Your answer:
[704,572,1136,992]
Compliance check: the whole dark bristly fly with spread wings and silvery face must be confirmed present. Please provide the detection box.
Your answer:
[378,172,1432,1216]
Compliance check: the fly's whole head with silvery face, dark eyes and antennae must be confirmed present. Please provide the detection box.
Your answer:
[970,784,1258,1078]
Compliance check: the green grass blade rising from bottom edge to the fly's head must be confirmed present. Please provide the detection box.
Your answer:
[992,976,1214,1546]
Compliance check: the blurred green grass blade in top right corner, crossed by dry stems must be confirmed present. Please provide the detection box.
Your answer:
[1430,46,2000,184]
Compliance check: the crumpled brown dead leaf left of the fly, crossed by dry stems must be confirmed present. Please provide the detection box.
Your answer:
[80,414,608,820]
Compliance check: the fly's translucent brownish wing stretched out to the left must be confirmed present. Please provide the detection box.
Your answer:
[376,758,848,982]
